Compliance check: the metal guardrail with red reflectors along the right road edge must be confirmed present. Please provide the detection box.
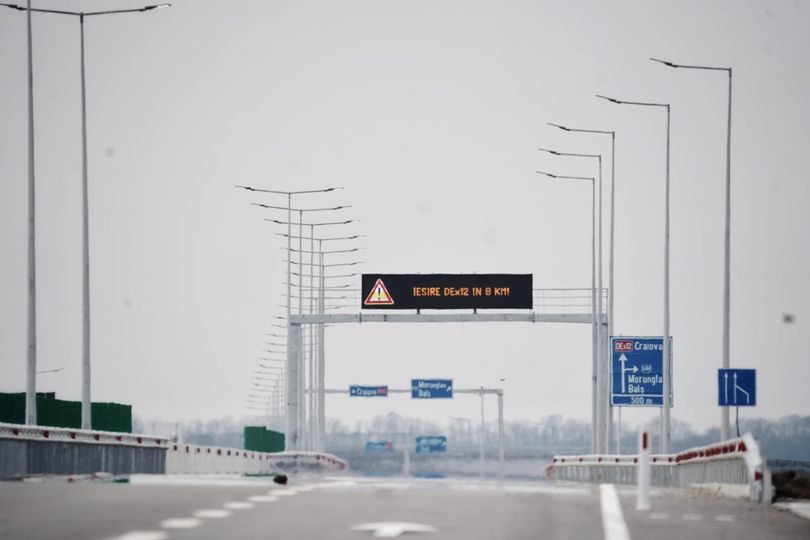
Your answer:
[546,433,772,503]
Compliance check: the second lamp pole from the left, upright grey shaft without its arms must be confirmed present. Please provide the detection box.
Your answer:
[79,13,93,429]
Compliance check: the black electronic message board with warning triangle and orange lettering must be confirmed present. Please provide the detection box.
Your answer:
[360,274,532,309]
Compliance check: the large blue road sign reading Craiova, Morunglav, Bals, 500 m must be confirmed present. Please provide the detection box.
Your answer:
[610,336,672,407]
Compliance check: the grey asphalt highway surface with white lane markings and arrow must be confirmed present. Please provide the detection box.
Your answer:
[0,476,810,540]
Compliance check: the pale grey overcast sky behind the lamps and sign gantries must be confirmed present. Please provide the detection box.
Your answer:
[0,0,810,428]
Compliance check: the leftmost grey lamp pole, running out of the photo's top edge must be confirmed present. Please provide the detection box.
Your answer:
[25,0,37,425]
